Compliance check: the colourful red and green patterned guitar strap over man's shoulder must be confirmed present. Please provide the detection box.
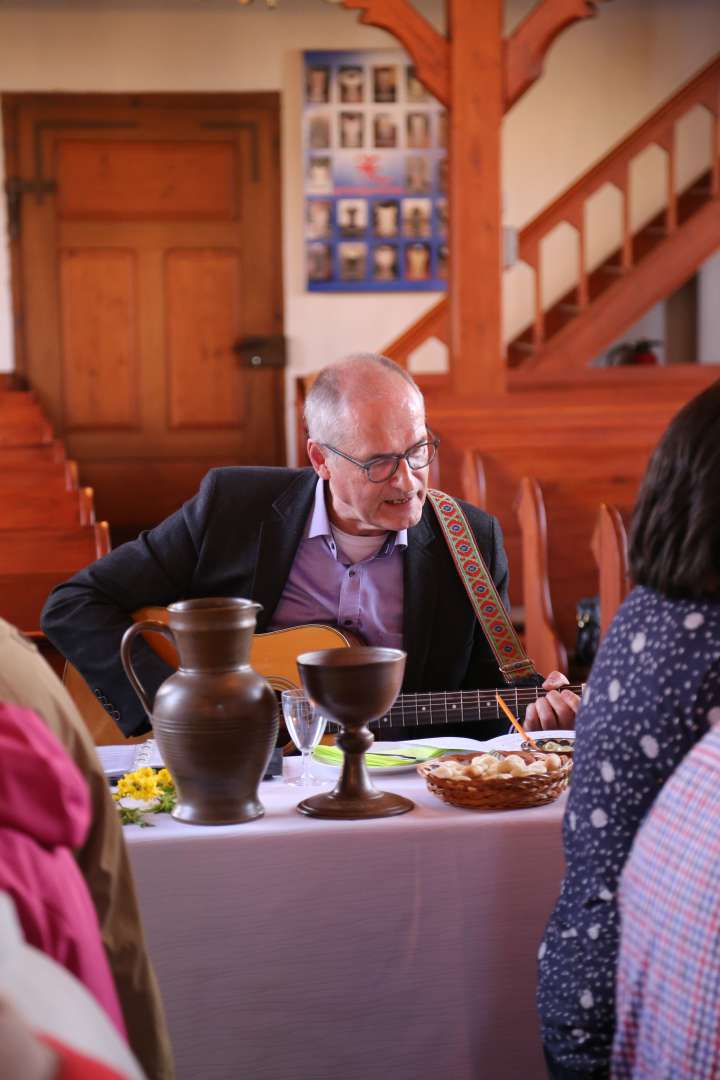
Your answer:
[427,488,538,684]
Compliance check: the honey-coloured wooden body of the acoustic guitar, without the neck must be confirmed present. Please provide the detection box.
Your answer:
[63,607,355,746]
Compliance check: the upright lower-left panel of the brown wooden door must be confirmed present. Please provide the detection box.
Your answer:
[60,248,139,430]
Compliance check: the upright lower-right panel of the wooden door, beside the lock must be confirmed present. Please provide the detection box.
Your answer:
[165,251,247,428]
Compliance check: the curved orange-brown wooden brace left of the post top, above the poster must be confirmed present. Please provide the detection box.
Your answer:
[342,0,450,105]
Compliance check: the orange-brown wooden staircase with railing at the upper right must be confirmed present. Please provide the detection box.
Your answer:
[385,56,720,375]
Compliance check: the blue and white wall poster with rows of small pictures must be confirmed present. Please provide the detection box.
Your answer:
[303,49,448,293]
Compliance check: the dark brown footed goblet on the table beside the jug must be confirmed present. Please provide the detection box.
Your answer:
[297,647,415,820]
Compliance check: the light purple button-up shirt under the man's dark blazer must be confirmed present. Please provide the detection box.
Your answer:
[269,480,407,649]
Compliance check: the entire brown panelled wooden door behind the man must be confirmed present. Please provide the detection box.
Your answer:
[3,94,285,529]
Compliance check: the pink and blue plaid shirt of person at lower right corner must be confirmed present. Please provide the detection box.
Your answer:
[612,730,720,1080]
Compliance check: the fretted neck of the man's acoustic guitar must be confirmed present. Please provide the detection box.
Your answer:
[371,686,583,728]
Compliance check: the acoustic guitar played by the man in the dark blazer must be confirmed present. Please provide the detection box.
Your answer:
[63,607,583,745]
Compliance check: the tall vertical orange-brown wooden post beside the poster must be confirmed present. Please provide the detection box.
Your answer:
[447,0,505,400]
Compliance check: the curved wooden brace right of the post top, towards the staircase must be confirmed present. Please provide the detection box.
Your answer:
[504,0,608,111]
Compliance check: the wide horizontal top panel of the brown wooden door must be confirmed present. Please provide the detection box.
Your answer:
[55,138,237,221]
